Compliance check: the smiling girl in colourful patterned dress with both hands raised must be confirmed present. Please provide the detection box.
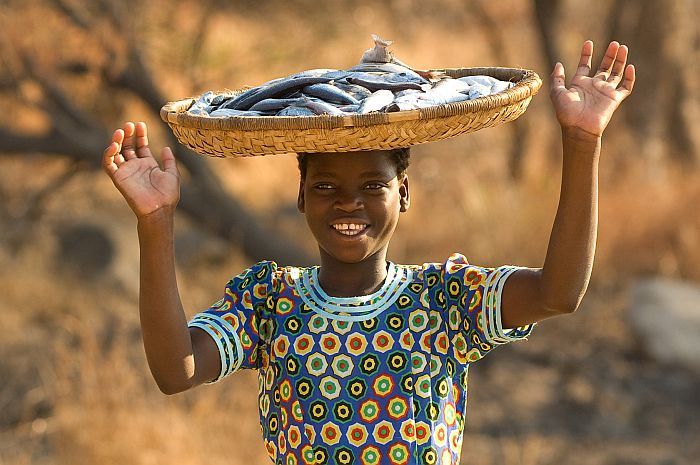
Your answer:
[104,41,635,465]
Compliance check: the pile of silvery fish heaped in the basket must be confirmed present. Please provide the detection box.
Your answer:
[187,35,514,118]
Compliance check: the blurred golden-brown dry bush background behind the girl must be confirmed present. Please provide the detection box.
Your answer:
[0,0,700,465]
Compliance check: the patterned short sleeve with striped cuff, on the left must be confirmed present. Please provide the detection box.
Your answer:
[188,262,276,383]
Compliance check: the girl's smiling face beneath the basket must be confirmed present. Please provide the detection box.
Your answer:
[298,151,409,263]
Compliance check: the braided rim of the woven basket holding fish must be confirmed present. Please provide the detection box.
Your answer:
[160,67,542,131]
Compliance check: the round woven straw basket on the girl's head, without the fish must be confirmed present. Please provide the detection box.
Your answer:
[160,68,542,157]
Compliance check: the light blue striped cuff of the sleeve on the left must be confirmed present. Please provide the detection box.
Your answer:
[187,313,244,384]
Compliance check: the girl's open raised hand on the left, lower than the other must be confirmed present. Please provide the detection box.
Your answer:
[102,121,180,218]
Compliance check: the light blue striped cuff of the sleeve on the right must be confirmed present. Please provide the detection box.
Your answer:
[481,266,534,345]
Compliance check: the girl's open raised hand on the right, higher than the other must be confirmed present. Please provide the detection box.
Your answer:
[549,40,635,137]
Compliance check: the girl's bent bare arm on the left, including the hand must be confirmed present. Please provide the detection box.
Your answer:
[103,122,220,394]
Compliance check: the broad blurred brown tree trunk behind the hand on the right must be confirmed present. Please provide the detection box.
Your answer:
[609,0,700,165]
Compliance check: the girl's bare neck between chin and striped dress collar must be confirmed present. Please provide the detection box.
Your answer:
[319,250,387,297]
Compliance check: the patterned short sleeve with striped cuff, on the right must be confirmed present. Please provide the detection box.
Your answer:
[441,254,534,362]
